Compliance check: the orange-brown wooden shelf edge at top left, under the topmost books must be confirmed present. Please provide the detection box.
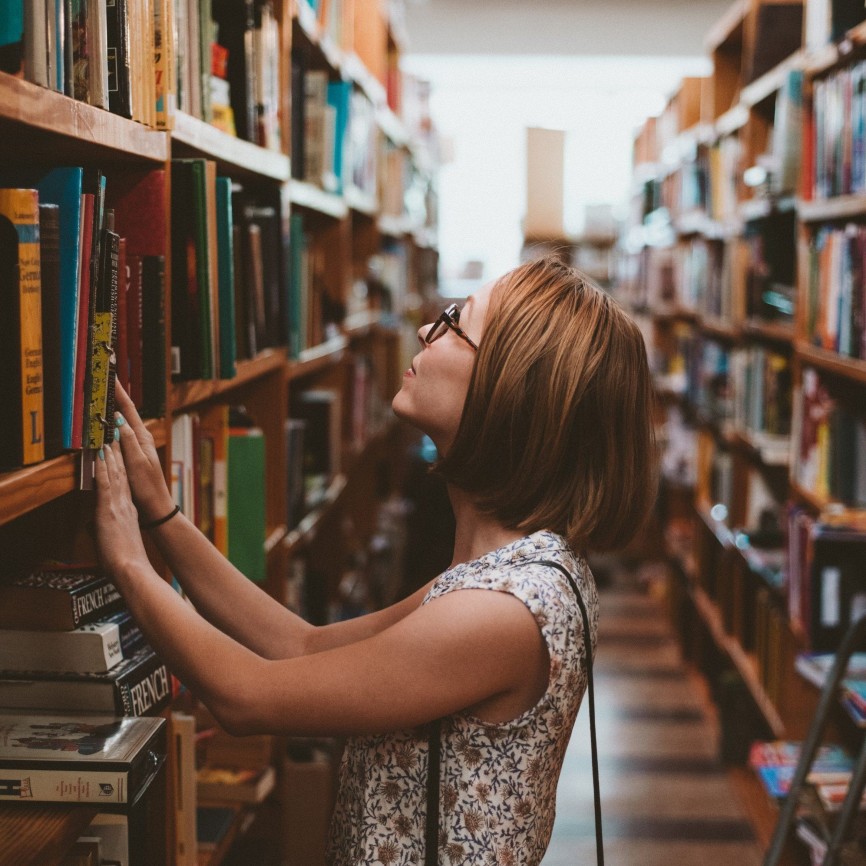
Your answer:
[0,72,169,163]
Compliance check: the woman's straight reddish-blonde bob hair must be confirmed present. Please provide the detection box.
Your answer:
[436,258,656,552]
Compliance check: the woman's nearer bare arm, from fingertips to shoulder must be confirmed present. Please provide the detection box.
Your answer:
[96,448,547,735]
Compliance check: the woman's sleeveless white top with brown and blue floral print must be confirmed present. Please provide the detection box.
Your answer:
[327,531,598,866]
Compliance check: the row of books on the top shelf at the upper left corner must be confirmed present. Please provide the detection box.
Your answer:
[0,0,171,128]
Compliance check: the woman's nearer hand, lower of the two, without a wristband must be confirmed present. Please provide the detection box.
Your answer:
[95,445,150,589]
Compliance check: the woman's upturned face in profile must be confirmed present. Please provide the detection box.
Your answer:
[392,284,493,454]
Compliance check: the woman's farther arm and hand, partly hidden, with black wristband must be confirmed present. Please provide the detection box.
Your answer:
[117,385,426,658]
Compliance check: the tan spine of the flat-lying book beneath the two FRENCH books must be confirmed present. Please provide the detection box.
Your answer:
[0,765,129,804]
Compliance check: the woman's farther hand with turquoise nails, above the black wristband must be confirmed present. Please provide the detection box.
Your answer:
[115,383,174,523]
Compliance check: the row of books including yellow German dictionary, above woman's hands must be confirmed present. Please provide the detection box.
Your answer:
[0,167,165,468]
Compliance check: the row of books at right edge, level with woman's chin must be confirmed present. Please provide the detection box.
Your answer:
[791,367,866,507]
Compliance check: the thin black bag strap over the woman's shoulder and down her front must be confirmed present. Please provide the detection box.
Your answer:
[424,559,604,866]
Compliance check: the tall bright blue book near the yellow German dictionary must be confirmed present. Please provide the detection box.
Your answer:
[36,167,84,449]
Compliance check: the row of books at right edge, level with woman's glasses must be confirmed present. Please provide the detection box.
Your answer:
[805,223,866,358]
